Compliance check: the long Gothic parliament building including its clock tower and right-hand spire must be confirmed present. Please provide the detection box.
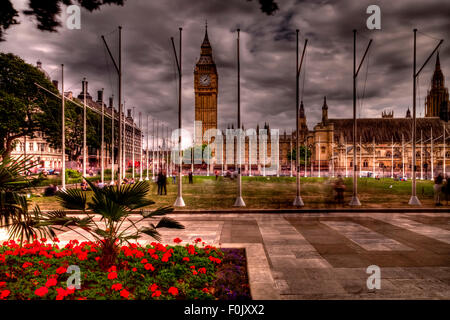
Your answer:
[194,25,450,179]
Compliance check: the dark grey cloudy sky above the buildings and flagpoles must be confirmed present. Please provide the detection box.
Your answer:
[0,0,450,138]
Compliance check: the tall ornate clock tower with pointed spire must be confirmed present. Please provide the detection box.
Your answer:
[194,26,219,142]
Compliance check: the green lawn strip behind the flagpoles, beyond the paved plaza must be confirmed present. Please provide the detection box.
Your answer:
[31,176,446,210]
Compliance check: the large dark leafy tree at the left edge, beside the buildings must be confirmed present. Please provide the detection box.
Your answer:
[0,53,59,160]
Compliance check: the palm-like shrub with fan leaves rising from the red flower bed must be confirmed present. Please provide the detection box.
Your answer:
[38,181,184,269]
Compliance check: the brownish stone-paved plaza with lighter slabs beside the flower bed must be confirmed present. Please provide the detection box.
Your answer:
[3,213,450,299]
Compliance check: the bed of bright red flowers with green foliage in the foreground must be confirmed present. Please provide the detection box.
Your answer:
[0,239,249,300]
